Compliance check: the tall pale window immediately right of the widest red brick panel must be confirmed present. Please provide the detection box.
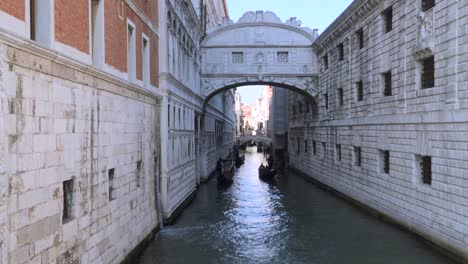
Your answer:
[91,0,104,67]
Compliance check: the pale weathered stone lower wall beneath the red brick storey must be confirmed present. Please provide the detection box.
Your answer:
[0,33,160,264]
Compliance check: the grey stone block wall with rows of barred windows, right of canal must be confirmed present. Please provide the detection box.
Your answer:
[289,0,468,259]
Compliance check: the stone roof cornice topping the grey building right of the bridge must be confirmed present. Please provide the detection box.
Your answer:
[313,0,384,54]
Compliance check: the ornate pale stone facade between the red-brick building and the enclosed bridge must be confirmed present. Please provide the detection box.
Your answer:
[159,0,235,223]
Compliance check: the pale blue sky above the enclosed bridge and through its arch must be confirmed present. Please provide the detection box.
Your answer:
[227,0,353,105]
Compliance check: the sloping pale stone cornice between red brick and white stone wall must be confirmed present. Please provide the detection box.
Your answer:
[0,29,161,105]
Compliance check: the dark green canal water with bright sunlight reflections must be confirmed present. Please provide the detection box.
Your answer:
[138,148,451,264]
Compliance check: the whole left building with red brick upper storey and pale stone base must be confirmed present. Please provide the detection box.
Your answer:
[0,0,160,264]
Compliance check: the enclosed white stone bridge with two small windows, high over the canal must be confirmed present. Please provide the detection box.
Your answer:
[201,11,318,105]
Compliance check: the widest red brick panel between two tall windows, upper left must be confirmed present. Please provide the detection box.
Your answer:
[54,0,89,54]
